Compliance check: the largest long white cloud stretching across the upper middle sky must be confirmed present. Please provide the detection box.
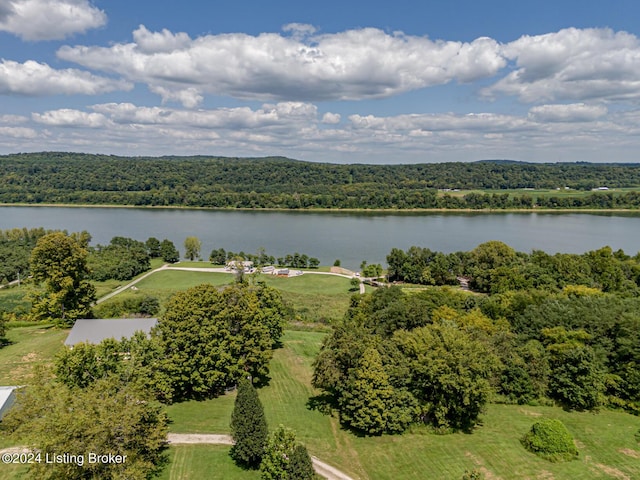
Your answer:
[58,24,506,106]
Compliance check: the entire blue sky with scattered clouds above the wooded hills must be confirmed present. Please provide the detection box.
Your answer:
[0,0,640,164]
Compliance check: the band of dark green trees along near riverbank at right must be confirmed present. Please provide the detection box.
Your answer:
[387,242,640,296]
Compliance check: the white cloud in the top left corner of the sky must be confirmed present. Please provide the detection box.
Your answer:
[0,0,107,40]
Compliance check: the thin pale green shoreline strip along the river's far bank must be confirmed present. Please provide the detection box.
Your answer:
[0,203,640,214]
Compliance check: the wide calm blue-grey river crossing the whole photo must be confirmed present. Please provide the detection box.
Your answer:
[0,206,640,269]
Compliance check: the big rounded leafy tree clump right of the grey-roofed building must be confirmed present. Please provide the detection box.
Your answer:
[159,284,287,400]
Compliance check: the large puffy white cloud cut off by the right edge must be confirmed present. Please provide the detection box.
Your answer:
[483,28,640,102]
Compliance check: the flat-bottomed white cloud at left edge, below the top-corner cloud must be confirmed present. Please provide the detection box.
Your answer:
[0,60,132,95]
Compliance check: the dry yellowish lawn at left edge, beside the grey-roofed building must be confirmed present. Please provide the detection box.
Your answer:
[0,326,69,385]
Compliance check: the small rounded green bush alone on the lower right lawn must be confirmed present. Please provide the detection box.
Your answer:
[521,419,578,461]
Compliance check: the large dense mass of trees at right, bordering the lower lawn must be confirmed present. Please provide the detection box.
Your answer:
[312,278,640,435]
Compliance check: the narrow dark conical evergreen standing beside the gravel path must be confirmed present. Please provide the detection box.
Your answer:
[231,378,269,468]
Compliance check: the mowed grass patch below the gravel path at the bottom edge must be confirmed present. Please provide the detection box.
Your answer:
[158,445,260,480]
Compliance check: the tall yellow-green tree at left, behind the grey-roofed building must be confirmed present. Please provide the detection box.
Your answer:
[29,232,96,325]
